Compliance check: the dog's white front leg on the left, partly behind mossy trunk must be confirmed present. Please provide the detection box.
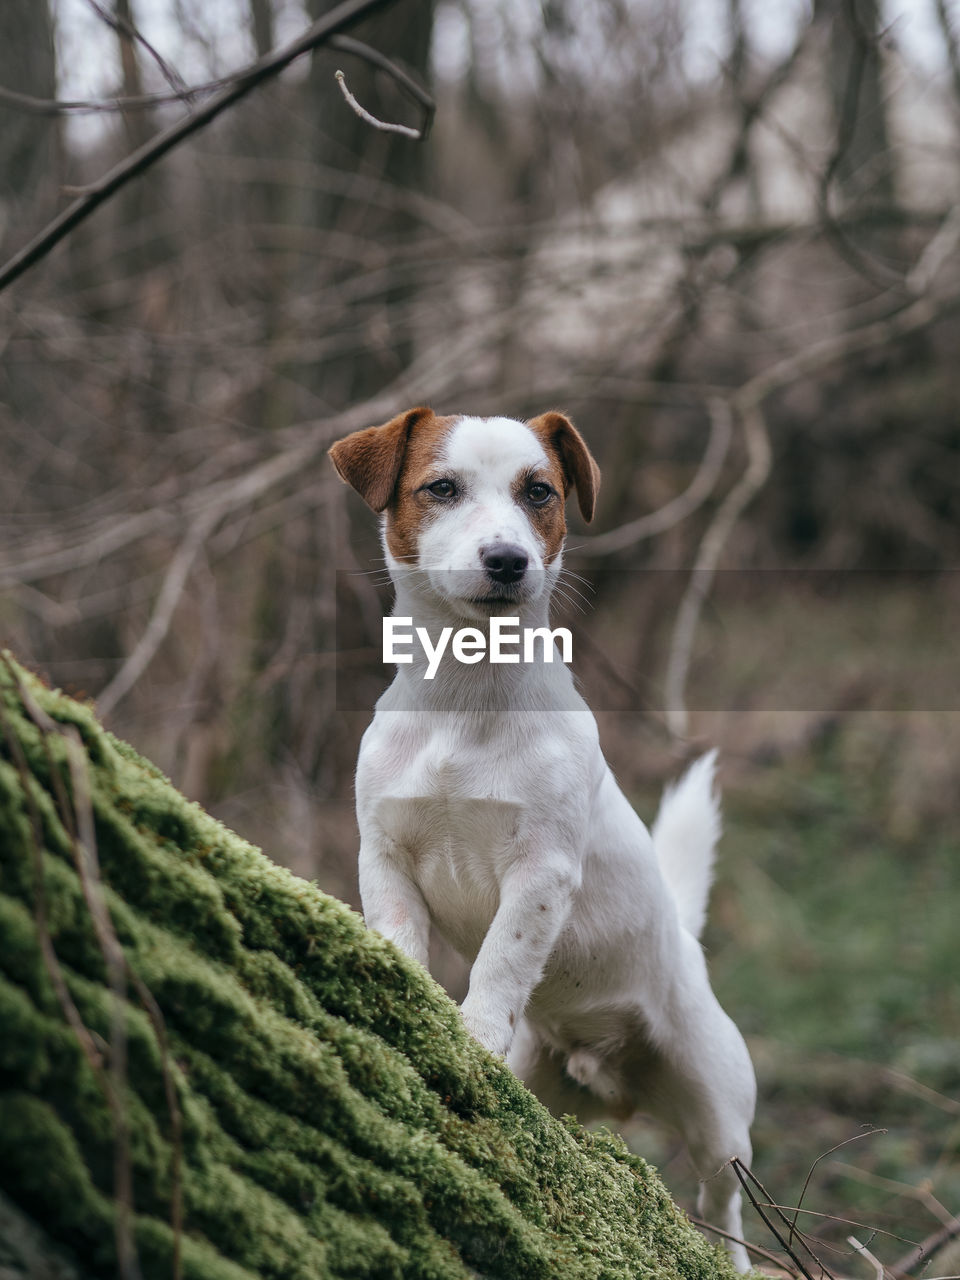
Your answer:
[358,835,430,969]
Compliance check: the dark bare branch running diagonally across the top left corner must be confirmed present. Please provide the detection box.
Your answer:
[0,0,407,289]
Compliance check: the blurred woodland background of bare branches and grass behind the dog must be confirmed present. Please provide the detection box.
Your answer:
[0,0,960,1277]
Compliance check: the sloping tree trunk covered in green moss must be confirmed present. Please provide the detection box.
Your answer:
[0,664,732,1280]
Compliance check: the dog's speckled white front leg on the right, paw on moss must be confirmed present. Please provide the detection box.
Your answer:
[462,855,580,1057]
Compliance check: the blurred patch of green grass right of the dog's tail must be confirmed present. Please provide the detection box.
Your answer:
[705,749,960,1059]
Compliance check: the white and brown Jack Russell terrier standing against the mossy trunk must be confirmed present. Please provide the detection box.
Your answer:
[330,408,755,1271]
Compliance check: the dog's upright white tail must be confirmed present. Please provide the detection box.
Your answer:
[650,750,723,938]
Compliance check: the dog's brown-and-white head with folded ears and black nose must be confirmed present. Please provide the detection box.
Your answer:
[330,408,599,620]
